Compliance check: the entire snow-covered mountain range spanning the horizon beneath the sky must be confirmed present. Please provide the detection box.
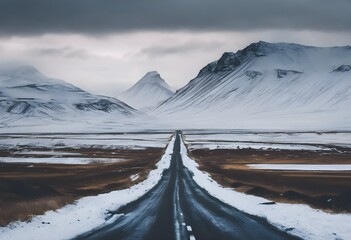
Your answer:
[0,42,351,131]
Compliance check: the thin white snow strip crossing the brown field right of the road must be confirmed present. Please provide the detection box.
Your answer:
[246,164,351,171]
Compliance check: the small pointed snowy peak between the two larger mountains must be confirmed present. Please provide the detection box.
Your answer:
[118,71,174,110]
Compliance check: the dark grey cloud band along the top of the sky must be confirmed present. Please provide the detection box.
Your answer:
[0,0,351,35]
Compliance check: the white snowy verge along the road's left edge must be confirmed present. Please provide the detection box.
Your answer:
[0,136,175,240]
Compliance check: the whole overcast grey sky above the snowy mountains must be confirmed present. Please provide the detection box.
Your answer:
[0,0,351,96]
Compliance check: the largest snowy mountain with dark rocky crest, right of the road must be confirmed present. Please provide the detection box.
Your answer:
[154,42,351,129]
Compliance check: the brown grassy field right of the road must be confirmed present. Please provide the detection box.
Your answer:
[190,149,351,213]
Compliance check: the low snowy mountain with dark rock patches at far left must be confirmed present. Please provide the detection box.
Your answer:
[0,66,137,123]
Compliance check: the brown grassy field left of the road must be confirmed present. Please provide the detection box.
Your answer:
[0,148,164,225]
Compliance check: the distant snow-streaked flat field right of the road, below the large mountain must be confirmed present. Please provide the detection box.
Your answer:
[185,130,351,151]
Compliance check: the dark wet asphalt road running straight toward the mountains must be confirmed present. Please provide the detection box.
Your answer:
[76,131,297,240]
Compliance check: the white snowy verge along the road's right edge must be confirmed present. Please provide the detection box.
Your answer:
[180,136,351,240]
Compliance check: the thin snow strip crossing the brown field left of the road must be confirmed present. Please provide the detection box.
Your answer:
[0,157,125,165]
